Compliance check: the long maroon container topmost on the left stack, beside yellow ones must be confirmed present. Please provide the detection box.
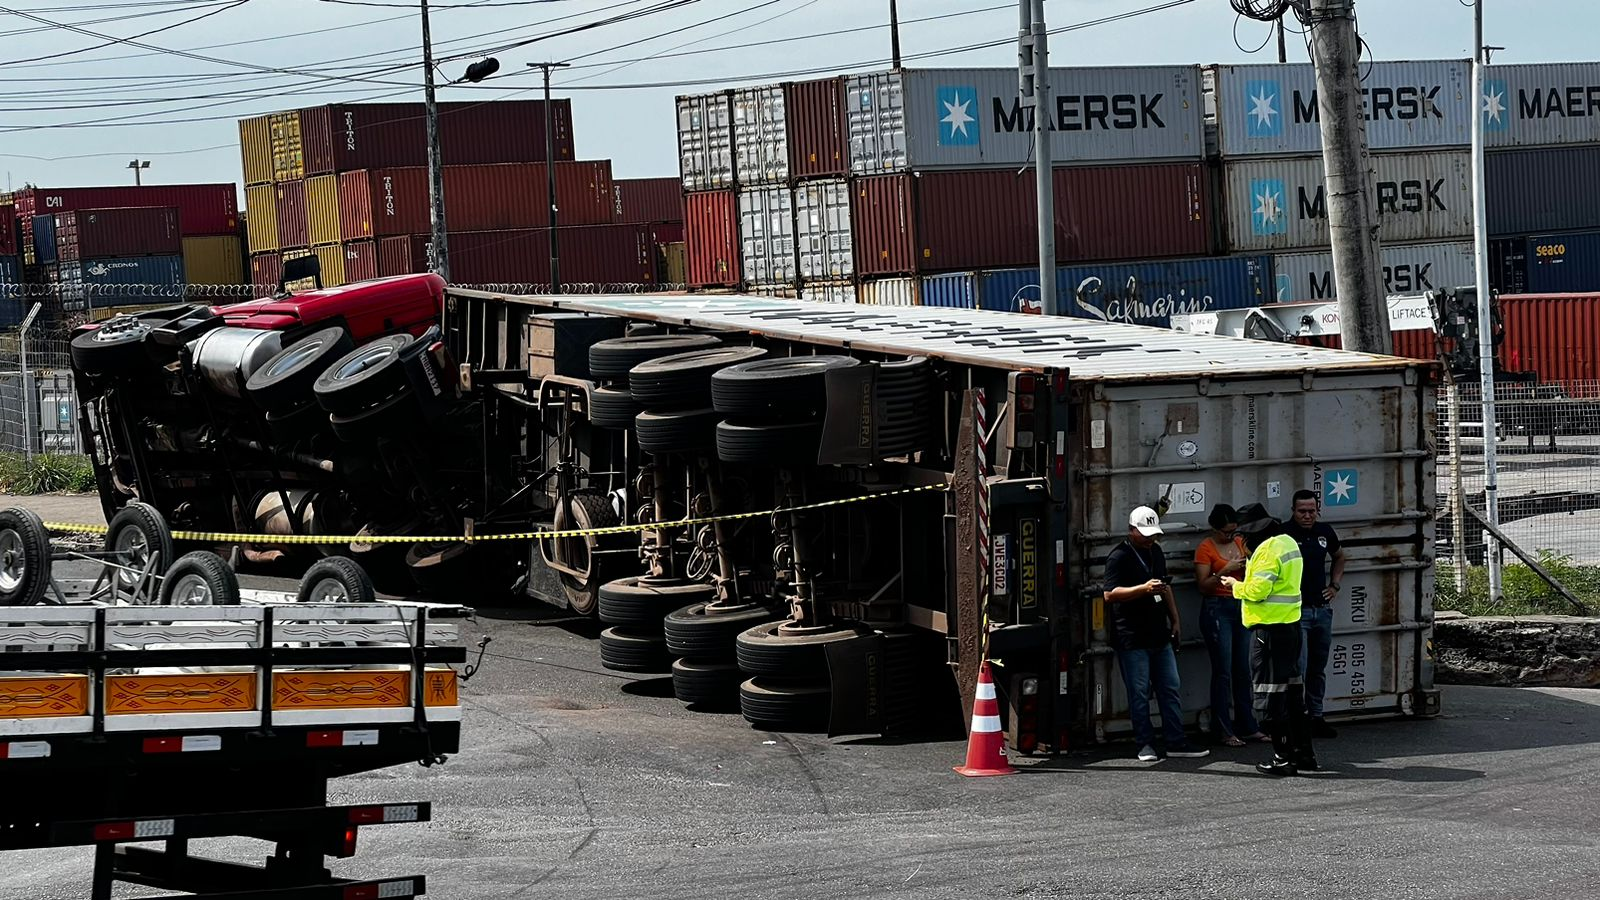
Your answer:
[299,99,573,175]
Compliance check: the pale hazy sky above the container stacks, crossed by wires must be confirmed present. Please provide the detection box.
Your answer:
[0,0,1600,189]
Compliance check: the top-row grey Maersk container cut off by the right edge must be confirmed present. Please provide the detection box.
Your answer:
[1480,62,1600,147]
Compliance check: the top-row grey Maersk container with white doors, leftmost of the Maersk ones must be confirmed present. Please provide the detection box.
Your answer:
[845,66,1205,175]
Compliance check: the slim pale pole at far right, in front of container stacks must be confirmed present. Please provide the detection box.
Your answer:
[1454,0,1502,602]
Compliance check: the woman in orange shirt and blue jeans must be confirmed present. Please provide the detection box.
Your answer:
[1195,503,1272,746]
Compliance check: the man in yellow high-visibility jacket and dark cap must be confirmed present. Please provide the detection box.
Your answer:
[1222,535,1317,777]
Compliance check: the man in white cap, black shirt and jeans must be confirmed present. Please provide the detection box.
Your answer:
[1102,506,1210,762]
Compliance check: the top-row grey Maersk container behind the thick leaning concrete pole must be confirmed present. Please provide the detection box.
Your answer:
[1216,59,1472,157]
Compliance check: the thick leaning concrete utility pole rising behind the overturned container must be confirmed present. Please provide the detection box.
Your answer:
[1306,0,1394,354]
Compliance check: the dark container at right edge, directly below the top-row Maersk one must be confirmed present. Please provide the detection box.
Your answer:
[1483,146,1600,235]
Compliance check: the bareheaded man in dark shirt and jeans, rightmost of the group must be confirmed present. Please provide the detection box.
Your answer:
[1278,490,1344,738]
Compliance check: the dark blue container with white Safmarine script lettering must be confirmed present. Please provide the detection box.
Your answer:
[979,256,1272,328]
